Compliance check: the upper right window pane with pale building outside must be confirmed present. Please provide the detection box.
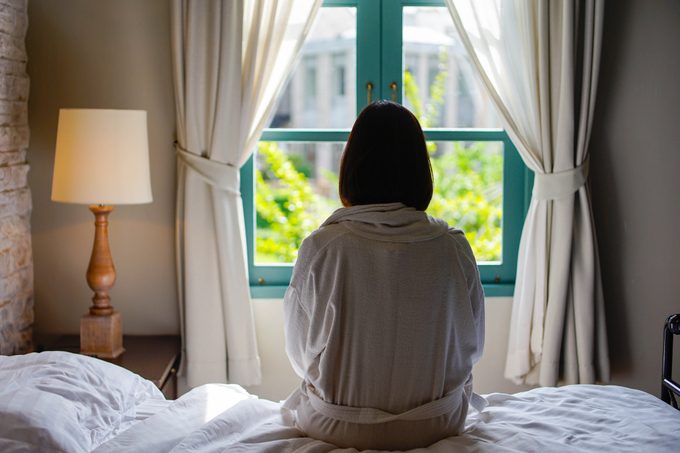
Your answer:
[403,7,501,128]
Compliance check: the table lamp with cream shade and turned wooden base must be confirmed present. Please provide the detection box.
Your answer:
[52,109,151,358]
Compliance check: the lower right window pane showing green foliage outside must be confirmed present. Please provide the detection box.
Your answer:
[427,142,503,262]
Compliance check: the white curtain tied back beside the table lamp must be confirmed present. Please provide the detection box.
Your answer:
[171,0,321,387]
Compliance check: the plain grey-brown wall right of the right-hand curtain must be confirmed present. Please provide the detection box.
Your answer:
[591,0,680,394]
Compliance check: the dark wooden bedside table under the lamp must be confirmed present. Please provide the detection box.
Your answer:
[37,335,181,399]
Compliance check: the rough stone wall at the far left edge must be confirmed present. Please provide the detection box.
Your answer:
[0,0,33,355]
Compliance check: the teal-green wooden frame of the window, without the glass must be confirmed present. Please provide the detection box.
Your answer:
[241,0,533,298]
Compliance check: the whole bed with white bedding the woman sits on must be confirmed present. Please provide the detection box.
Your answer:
[0,315,680,453]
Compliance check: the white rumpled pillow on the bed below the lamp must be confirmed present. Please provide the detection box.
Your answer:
[0,351,164,452]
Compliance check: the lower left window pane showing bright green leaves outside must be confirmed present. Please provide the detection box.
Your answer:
[255,142,345,265]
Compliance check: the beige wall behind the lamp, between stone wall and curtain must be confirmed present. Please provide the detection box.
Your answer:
[27,0,179,334]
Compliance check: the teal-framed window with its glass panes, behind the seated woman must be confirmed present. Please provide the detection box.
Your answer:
[241,0,530,297]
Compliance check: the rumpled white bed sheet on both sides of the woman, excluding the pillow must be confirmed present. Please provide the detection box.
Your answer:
[96,384,680,453]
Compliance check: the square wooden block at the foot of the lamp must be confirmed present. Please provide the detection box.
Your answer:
[80,311,125,359]
